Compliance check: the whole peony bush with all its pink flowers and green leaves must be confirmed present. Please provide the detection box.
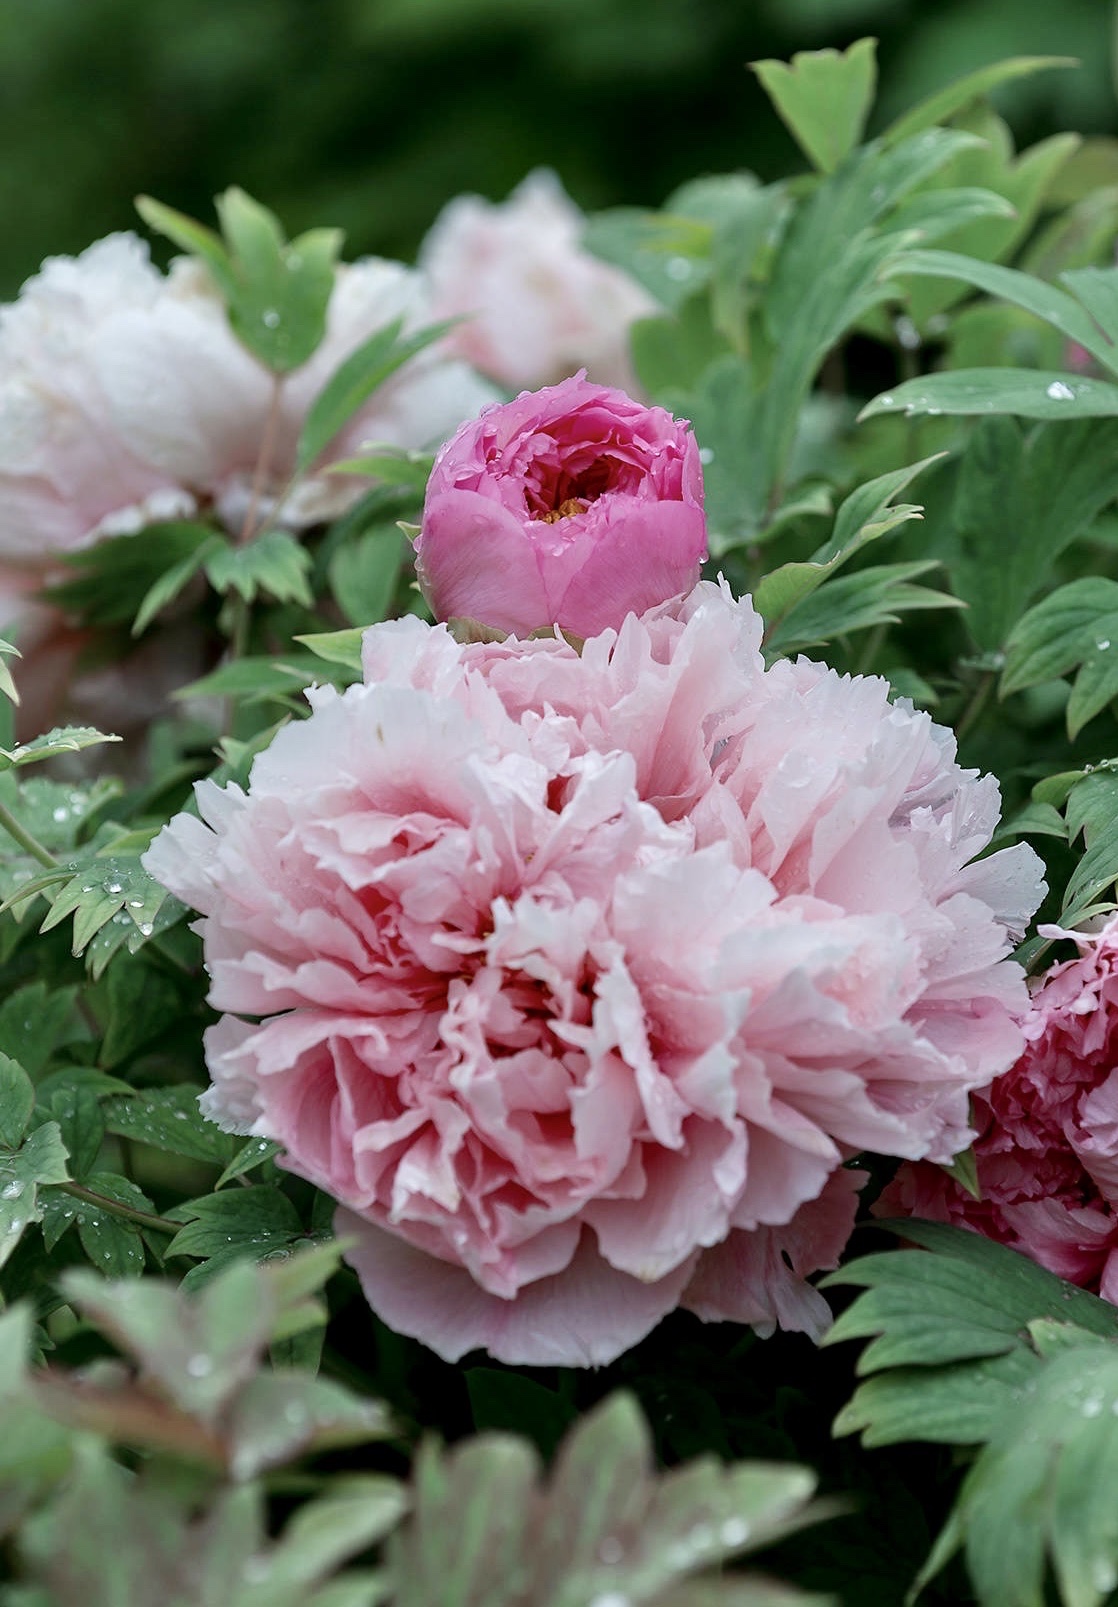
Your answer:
[8,40,1118,1607]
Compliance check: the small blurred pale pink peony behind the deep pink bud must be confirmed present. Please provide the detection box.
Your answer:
[419,169,662,391]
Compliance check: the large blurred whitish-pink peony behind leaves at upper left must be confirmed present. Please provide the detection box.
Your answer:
[0,235,495,739]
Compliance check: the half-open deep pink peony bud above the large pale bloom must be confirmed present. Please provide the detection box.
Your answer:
[416,374,707,636]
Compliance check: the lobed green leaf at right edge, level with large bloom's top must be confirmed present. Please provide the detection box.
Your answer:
[1001,577,1118,739]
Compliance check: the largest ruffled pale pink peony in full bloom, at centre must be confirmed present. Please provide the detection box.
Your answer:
[145,585,1041,1364]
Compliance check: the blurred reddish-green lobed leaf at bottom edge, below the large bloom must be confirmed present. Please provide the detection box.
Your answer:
[387,1393,824,1607]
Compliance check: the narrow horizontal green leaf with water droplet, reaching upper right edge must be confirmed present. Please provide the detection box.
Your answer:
[858,368,1118,419]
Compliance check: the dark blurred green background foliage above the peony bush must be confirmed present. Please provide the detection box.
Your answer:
[0,0,1115,296]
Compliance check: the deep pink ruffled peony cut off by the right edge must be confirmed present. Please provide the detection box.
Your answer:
[877,919,1118,1305]
